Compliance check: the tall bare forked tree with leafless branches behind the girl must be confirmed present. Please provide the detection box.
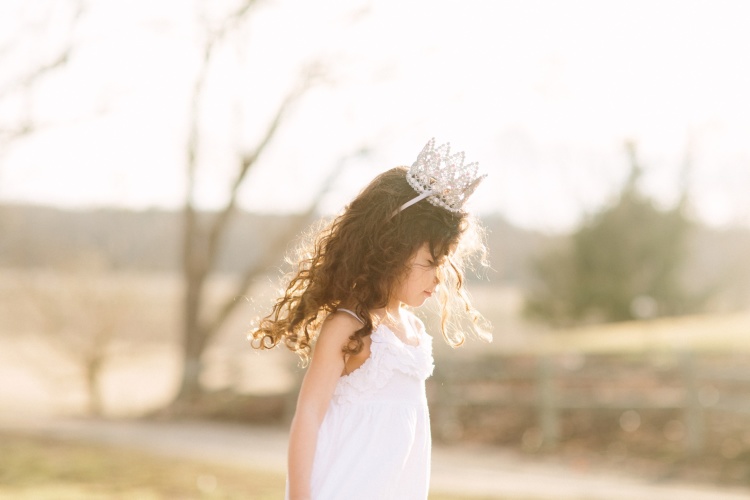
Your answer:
[172,0,362,411]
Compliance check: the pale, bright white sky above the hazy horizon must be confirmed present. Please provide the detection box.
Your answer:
[0,0,750,230]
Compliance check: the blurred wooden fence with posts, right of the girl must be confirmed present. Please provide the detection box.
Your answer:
[429,351,750,454]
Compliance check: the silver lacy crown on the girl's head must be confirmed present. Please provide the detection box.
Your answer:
[399,137,487,212]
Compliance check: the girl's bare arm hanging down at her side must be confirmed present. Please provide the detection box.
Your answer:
[287,314,361,500]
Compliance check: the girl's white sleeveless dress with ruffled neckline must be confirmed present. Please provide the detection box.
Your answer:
[311,309,434,500]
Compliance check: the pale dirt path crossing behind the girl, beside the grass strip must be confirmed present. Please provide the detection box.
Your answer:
[0,417,750,500]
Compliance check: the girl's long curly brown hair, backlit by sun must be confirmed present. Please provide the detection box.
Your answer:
[249,167,489,363]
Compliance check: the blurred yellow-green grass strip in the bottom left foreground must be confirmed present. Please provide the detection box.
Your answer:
[0,434,521,500]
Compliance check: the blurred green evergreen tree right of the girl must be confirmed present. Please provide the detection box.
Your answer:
[527,145,698,325]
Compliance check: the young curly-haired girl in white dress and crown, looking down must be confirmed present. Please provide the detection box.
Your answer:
[251,139,484,500]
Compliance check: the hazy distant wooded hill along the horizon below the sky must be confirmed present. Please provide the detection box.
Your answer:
[0,205,750,309]
